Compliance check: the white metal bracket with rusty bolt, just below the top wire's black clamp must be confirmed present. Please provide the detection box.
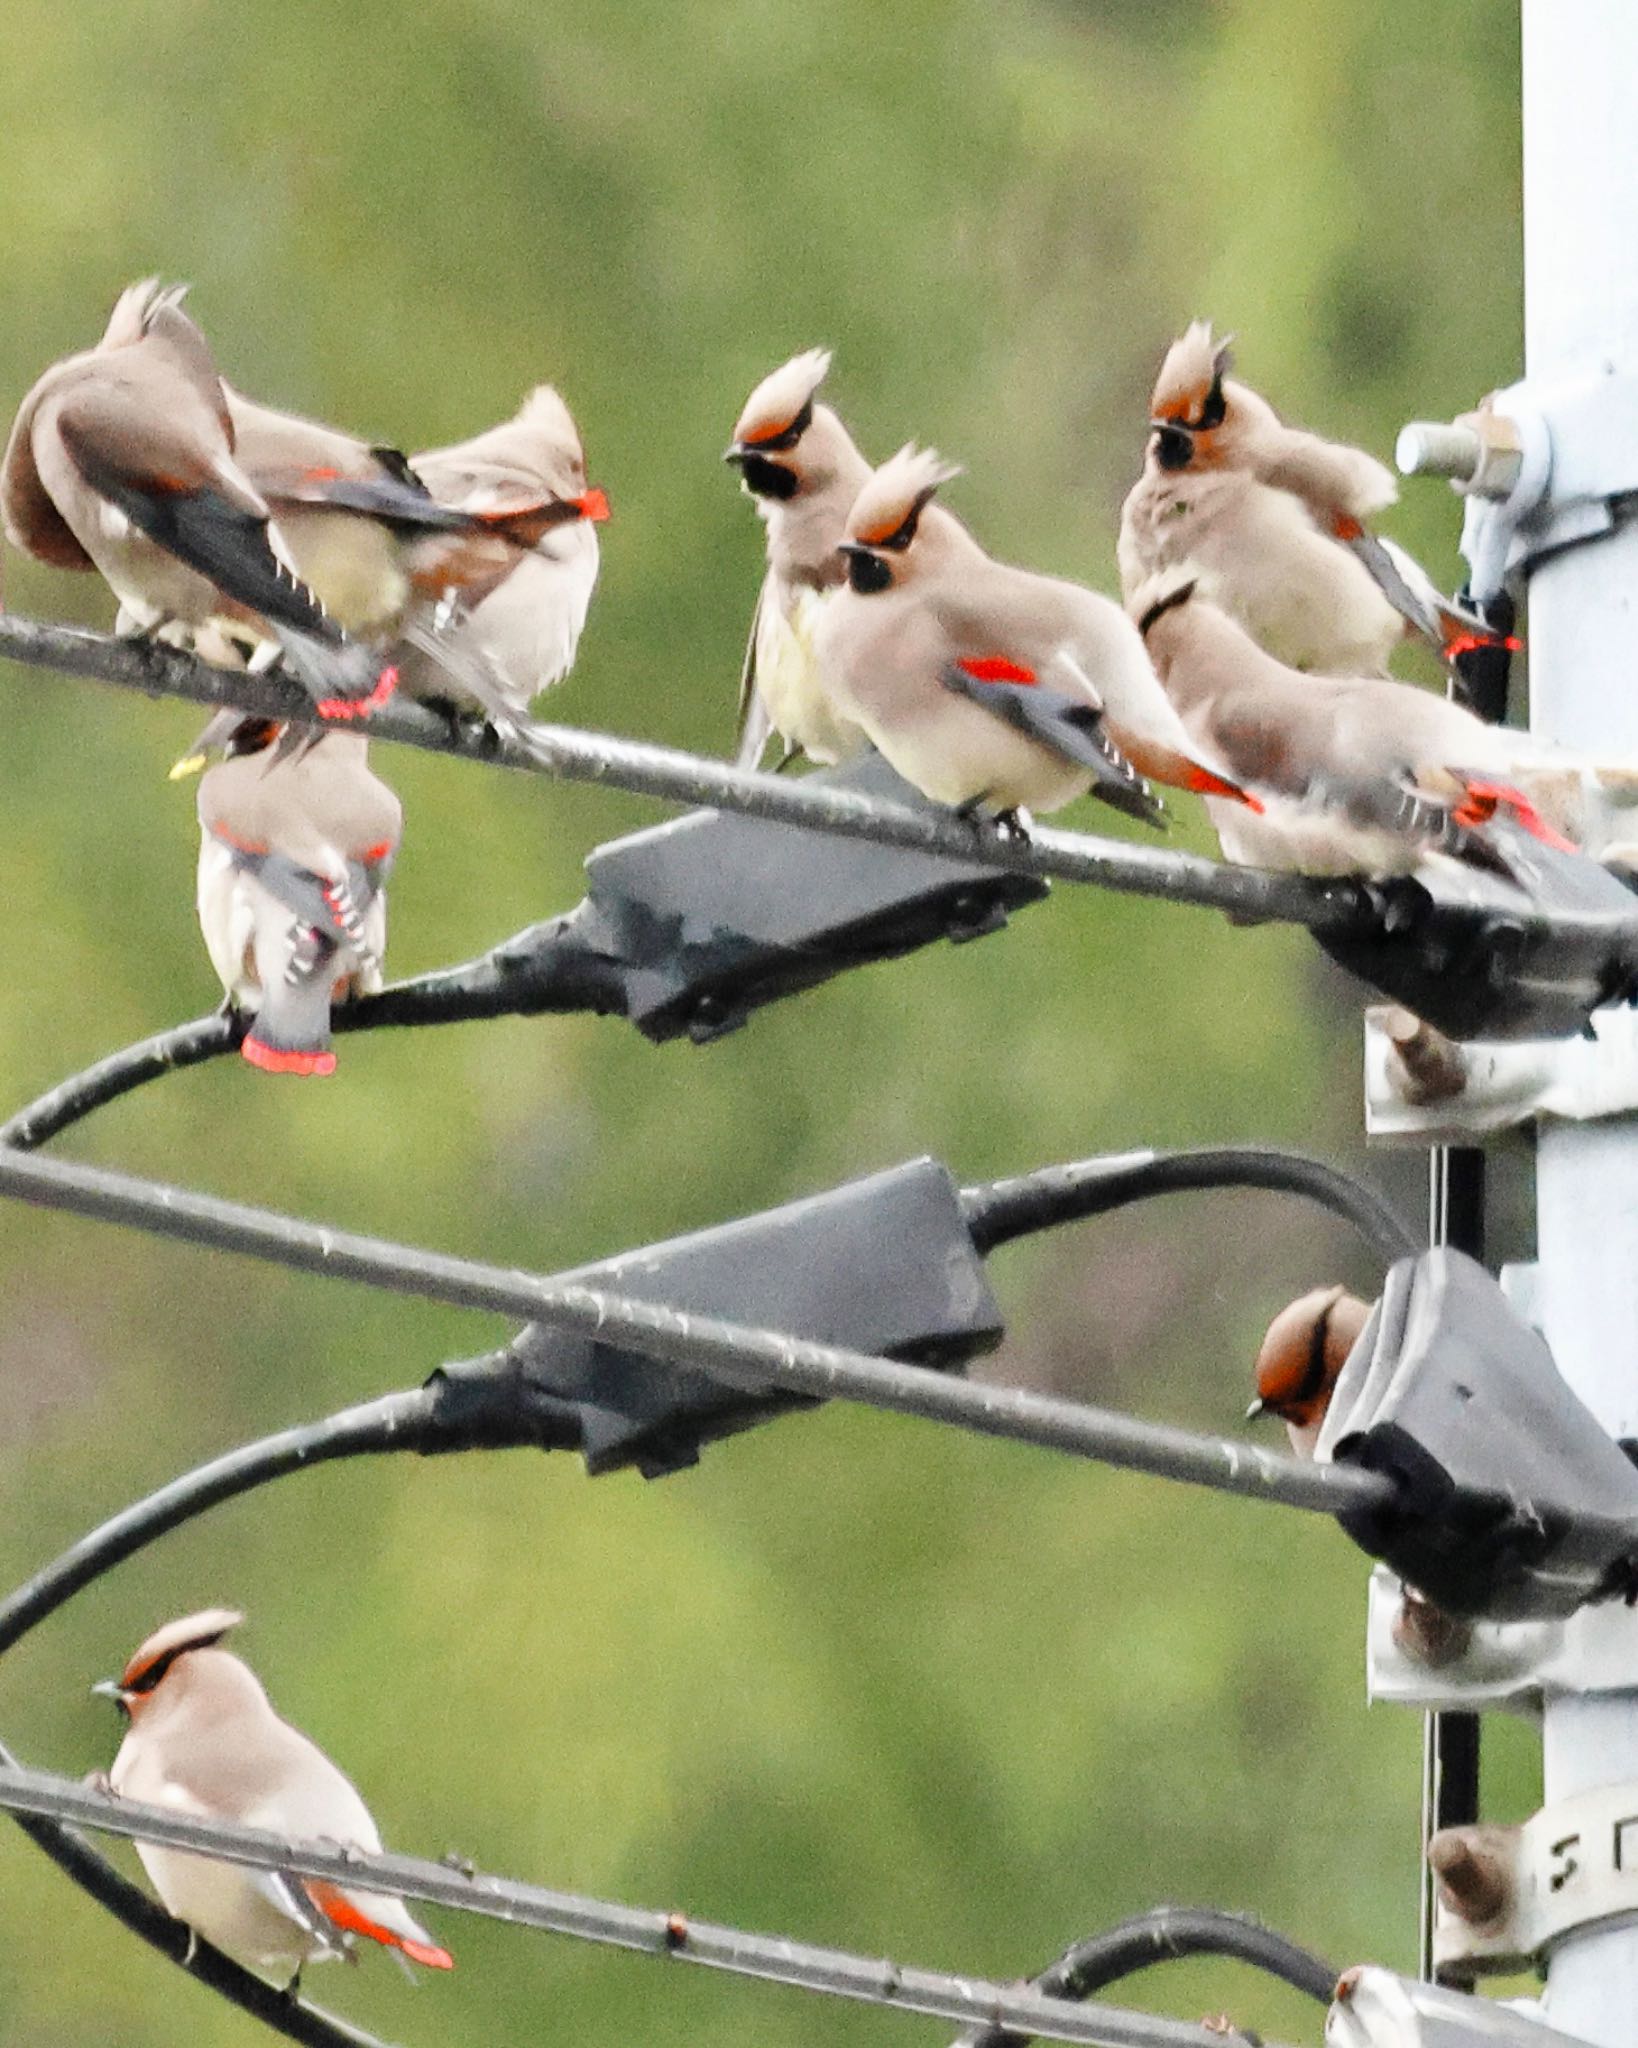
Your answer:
[1366,1004,1638,1145]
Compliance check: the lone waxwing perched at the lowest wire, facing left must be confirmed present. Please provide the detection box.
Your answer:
[92,1608,455,1985]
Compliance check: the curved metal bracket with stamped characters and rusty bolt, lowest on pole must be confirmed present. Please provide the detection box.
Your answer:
[1431,1786,1638,1974]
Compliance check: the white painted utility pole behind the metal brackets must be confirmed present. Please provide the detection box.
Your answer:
[1523,0,1638,2048]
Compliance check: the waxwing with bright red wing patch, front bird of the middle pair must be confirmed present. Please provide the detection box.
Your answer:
[815,449,1241,821]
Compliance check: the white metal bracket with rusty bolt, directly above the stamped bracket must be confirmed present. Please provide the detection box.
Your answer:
[1366,1565,1638,1712]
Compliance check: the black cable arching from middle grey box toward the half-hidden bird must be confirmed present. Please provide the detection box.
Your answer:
[960,1145,1421,1266]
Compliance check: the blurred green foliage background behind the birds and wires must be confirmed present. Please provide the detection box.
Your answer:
[0,0,1532,2048]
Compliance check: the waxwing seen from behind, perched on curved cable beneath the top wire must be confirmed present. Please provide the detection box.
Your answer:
[199,719,403,1073]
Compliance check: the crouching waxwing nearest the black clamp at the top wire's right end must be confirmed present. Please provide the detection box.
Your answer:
[1132,567,1638,877]
